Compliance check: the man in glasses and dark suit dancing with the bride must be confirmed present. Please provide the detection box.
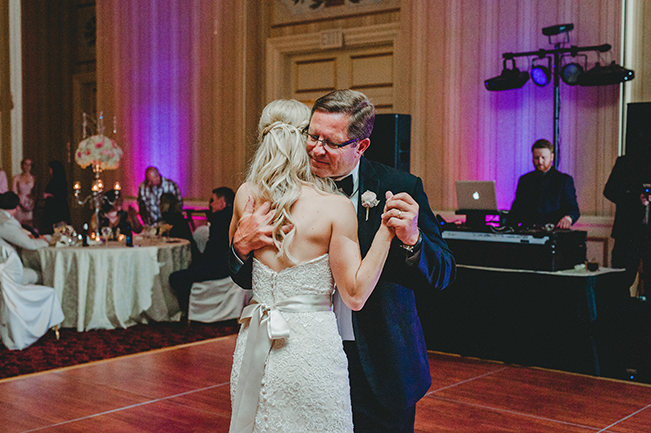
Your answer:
[230,90,456,433]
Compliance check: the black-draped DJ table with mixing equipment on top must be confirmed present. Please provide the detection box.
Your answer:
[417,226,628,375]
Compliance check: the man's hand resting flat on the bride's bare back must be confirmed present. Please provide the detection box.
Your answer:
[233,196,292,259]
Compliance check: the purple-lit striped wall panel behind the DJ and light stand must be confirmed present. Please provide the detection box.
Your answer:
[410,0,621,215]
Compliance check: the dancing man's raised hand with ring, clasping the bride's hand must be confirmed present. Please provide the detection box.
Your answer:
[382,191,420,245]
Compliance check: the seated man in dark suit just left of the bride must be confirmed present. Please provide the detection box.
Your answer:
[169,187,235,320]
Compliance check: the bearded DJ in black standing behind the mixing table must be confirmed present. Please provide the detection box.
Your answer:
[506,139,581,229]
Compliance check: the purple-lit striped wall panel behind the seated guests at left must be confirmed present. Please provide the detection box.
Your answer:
[97,0,245,200]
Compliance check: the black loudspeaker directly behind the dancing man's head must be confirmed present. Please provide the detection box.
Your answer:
[364,114,411,172]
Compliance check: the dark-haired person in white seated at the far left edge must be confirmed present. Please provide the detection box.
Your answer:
[0,191,48,285]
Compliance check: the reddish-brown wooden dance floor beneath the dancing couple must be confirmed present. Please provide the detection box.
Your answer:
[0,336,651,433]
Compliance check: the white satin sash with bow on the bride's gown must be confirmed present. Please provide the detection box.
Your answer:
[229,295,331,433]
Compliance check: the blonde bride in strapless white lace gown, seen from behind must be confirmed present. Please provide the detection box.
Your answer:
[230,100,394,433]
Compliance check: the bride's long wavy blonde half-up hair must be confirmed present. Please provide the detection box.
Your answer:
[246,99,336,263]
